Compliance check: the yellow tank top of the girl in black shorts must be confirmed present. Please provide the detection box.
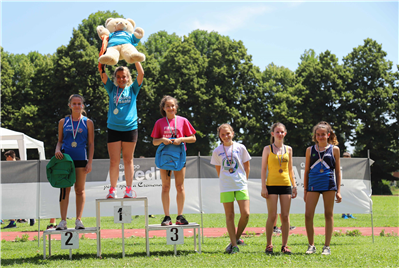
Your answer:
[266,146,291,186]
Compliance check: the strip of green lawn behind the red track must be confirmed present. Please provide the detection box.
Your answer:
[0,196,399,232]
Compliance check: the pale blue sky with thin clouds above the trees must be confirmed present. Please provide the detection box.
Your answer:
[0,0,398,70]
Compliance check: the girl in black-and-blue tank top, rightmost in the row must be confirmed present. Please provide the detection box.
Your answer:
[304,121,342,255]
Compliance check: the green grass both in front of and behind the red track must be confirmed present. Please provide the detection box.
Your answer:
[0,196,399,267]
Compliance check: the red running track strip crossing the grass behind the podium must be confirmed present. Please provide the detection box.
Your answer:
[0,227,399,241]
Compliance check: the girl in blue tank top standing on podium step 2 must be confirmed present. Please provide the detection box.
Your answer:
[55,94,94,230]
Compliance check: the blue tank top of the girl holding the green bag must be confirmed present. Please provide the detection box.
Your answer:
[61,116,88,161]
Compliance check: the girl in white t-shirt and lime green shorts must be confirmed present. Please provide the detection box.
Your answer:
[211,124,251,254]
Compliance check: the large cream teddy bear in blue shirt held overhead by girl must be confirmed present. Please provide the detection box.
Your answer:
[97,18,145,65]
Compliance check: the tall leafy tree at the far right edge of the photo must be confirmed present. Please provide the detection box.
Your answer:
[343,38,399,187]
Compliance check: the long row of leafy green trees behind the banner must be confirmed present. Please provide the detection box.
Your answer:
[0,11,399,191]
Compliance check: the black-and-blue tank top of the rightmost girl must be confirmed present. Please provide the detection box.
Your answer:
[307,145,337,192]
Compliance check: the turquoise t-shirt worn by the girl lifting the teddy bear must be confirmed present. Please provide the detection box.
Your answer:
[104,78,141,131]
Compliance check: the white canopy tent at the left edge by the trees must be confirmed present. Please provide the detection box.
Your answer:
[0,127,46,160]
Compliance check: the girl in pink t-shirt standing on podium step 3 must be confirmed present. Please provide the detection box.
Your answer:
[151,96,196,226]
